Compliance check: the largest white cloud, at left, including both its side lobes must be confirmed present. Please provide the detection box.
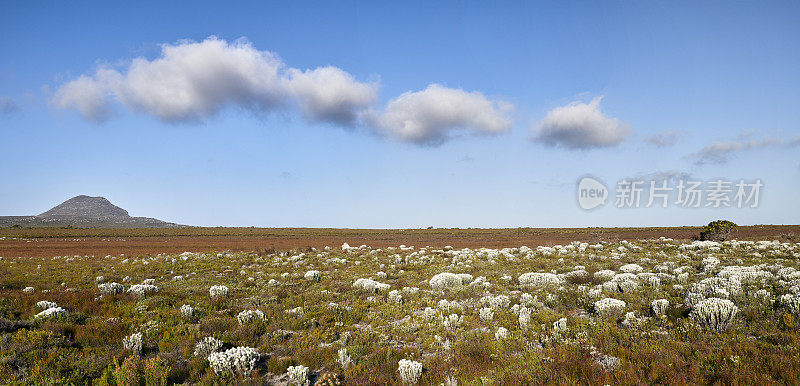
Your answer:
[51,37,376,123]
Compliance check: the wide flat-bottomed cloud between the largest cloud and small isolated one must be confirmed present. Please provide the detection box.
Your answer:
[370,84,513,145]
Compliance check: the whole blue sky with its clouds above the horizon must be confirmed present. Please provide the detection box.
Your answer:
[0,1,800,228]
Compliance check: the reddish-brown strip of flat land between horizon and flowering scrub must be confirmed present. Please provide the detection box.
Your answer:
[0,225,800,257]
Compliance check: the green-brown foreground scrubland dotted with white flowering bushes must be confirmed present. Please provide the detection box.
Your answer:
[0,238,800,385]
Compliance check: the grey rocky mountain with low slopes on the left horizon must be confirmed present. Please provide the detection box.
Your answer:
[0,195,183,228]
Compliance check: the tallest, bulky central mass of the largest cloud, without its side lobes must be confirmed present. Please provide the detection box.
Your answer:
[114,37,283,121]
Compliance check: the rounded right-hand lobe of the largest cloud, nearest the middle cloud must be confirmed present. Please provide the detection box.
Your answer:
[286,66,378,125]
